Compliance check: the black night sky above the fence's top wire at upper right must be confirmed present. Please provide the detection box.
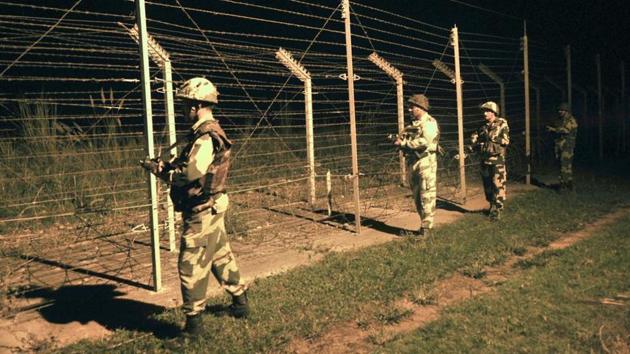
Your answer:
[361,0,630,80]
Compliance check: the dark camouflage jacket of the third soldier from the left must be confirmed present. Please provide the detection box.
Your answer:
[471,117,510,165]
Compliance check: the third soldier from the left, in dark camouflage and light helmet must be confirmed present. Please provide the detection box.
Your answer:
[471,101,510,220]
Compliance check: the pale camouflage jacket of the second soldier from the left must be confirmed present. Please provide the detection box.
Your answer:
[400,113,440,163]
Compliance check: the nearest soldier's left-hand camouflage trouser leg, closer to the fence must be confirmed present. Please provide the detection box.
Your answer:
[178,213,212,316]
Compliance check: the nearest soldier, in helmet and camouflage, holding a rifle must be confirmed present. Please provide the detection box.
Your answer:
[142,77,249,335]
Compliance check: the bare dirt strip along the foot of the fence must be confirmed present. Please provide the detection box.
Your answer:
[0,184,536,353]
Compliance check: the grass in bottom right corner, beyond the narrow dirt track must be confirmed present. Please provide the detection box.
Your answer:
[382,210,630,353]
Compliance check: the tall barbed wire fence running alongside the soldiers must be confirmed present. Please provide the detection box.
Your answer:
[0,0,624,317]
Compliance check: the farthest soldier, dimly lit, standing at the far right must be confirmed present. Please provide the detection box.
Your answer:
[547,103,578,191]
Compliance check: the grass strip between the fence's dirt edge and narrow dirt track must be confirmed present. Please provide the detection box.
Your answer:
[58,167,630,353]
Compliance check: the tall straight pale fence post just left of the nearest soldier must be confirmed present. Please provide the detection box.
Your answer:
[136,0,162,291]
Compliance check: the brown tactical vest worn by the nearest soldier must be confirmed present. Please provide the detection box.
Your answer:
[170,120,232,212]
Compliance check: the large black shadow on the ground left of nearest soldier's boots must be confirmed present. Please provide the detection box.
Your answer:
[21,284,179,338]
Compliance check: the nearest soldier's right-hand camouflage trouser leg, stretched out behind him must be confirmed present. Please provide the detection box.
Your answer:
[212,213,246,296]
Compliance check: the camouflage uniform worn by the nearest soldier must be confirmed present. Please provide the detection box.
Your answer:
[171,117,246,316]
